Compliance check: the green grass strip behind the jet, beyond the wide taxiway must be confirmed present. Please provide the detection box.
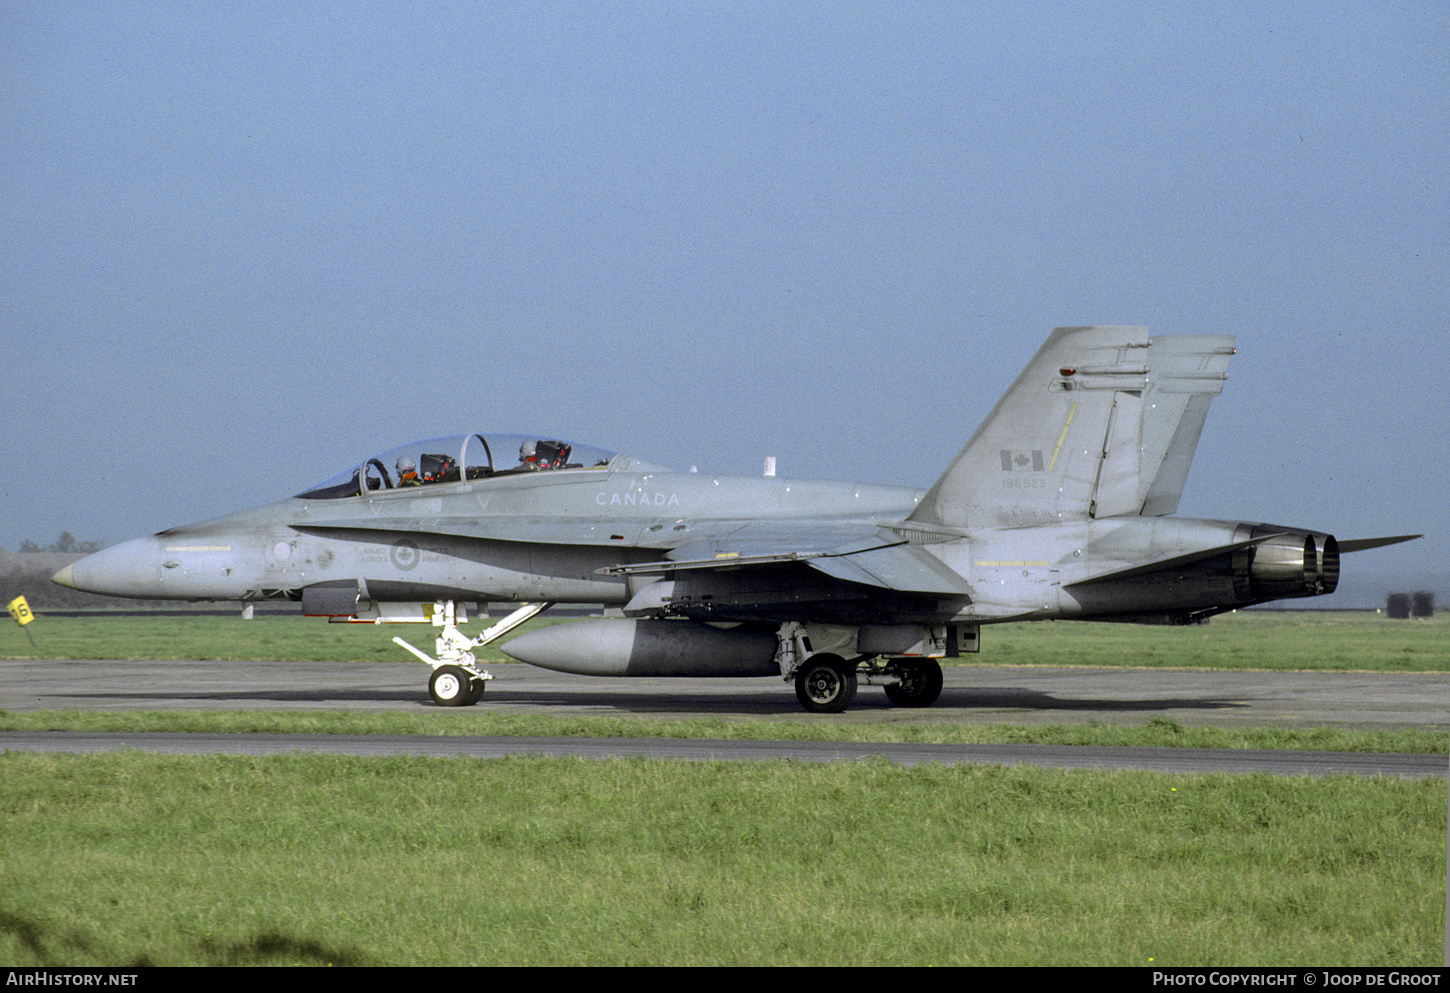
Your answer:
[11,610,1450,673]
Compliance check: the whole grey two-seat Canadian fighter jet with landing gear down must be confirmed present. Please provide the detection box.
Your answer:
[55,326,1415,712]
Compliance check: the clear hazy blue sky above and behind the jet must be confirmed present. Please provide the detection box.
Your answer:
[0,0,1450,596]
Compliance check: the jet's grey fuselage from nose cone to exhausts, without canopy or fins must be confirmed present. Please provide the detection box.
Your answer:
[58,446,1337,623]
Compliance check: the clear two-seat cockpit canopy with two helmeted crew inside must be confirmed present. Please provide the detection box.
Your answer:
[297,435,618,500]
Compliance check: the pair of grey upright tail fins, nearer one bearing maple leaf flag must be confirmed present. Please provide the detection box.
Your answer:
[909,326,1234,528]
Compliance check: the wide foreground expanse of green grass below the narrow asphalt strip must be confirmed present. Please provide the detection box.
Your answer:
[0,754,1447,967]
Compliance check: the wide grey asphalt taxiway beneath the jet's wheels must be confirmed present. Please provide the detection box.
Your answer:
[0,660,1450,731]
